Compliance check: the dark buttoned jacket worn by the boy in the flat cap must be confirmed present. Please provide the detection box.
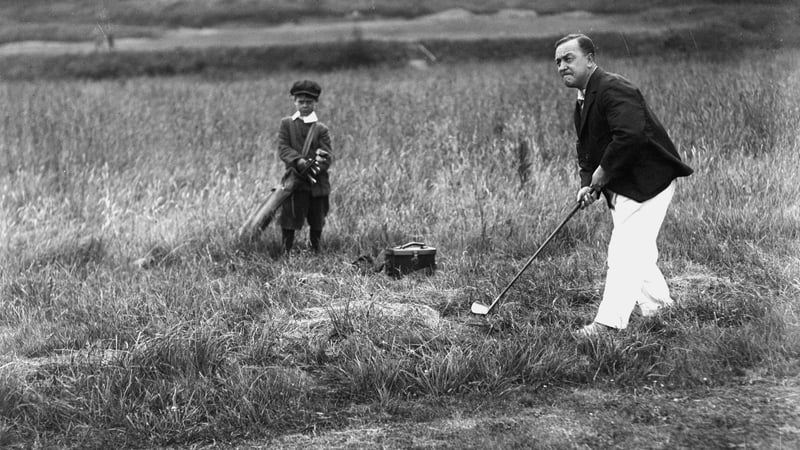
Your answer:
[278,117,333,197]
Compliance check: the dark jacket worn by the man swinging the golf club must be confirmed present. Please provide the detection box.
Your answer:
[575,67,692,202]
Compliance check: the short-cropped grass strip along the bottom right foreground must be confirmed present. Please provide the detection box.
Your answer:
[252,377,800,449]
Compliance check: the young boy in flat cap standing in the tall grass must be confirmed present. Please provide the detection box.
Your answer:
[278,80,333,254]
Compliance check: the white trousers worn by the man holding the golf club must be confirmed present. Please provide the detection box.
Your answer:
[595,181,675,329]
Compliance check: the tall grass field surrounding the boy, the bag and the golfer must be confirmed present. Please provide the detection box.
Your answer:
[0,52,800,447]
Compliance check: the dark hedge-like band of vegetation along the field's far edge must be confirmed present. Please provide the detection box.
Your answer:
[0,24,800,80]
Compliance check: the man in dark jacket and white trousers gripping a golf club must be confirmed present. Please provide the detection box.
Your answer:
[555,34,692,337]
